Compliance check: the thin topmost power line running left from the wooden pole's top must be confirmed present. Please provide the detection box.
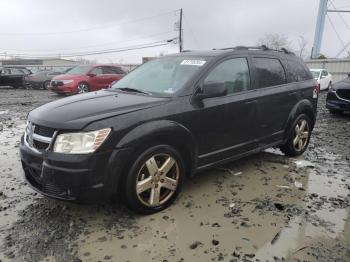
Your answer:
[0,10,178,36]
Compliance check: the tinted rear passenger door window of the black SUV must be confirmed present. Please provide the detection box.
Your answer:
[253,57,286,88]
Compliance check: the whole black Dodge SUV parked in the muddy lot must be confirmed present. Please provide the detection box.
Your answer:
[20,47,318,213]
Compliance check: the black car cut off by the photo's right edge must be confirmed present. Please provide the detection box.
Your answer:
[326,74,350,114]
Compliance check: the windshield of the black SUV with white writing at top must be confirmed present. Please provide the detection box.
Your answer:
[112,57,207,95]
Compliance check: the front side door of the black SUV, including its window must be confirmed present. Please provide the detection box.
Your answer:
[196,57,257,165]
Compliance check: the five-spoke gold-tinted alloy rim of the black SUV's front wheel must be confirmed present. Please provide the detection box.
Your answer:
[136,154,180,207]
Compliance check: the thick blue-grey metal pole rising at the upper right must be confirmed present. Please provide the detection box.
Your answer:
[311,0,328,59]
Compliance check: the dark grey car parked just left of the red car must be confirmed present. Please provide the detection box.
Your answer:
[24,70,65,89]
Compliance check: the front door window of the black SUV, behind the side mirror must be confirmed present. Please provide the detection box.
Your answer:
[204,58,250,94]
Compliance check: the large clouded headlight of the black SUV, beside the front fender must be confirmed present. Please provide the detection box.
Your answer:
[53,128,111,154]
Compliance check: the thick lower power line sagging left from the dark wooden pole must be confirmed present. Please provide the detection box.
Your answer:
[3,39,174,58]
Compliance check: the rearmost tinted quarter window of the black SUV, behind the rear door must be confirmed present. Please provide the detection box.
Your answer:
[286,60,314,82]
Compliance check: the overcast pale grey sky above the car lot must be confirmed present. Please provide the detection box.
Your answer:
[0,0,350,64]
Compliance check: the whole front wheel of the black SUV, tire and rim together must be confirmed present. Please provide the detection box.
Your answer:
[124,145,185,214]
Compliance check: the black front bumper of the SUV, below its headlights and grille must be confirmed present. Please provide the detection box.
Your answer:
[20,137,129,201]
